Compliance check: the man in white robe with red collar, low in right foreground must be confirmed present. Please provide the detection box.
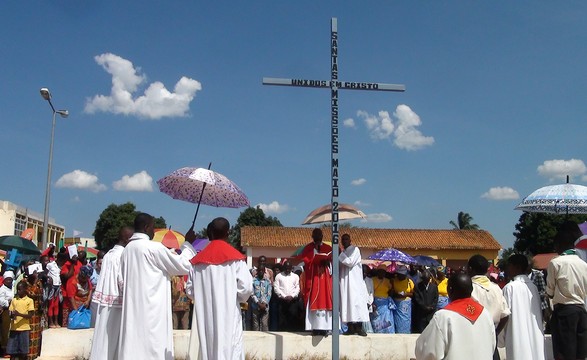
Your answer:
[415,273,496,360]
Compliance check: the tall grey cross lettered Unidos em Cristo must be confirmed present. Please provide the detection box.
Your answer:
[263,18,406,360]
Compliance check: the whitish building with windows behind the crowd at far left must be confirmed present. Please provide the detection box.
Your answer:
[0,200,65,246]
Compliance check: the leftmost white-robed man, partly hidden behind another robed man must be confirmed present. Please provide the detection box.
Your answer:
[90,226,133,360]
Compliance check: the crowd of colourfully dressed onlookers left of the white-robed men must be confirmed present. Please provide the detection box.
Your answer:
[0,239,104,359]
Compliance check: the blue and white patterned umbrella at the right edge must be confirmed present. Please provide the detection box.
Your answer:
[515,182,587,214]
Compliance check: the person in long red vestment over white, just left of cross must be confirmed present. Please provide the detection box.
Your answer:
[298,228,332,336]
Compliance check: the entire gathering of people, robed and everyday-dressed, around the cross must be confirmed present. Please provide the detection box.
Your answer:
[0,213,587,360]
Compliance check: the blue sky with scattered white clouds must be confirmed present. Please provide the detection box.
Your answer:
[0,0,587,247]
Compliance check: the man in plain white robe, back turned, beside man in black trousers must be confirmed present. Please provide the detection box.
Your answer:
[503,254,544,360]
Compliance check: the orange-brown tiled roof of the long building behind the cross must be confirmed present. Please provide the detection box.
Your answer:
[241,226,501,250]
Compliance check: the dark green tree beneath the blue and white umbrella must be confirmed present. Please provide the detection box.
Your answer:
[514,212,587,255]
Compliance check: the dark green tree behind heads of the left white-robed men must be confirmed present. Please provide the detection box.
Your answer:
[93,202,167,251]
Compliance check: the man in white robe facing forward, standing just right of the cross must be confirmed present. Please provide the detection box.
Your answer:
[339,234,369,336]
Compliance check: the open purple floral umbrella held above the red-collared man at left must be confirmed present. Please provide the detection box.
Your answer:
[157,164,250,228]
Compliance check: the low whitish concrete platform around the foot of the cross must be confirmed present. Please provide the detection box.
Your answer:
[40,329,553,360]
